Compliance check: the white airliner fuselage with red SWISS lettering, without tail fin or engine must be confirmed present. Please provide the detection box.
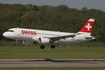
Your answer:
[3,28,94,44]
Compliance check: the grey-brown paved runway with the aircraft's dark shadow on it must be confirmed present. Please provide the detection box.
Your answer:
[0,58,105,68]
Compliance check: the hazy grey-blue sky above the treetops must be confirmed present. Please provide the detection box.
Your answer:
[0,0,105,11]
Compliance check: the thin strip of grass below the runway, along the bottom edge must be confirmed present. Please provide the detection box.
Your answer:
[0,68,105,70]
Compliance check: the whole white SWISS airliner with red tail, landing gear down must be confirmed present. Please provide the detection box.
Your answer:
[3,19,95,49]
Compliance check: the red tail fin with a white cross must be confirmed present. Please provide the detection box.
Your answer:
[78,19,95,35]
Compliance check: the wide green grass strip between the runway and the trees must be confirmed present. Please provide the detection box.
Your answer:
[0,46,105,58]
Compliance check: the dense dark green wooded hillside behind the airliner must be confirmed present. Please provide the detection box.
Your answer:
[0,3,105,41]
